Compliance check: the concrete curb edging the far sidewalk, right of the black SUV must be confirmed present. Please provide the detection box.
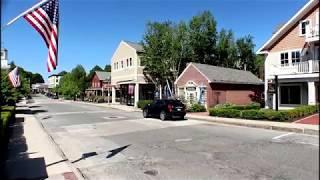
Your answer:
[186,114,319,135]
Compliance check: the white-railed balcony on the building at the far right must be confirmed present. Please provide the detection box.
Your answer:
[273,60,319,75]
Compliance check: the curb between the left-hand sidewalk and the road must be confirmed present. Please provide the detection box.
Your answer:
[27,105,86,180]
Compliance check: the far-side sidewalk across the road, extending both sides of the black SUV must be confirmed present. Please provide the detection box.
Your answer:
[62,100,319,135]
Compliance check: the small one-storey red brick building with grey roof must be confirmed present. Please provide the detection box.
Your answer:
[175,63,263,108]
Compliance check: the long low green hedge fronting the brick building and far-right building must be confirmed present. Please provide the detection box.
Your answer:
[209,105,319,121]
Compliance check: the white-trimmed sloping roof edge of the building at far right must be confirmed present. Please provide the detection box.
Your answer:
[257,0,319,54]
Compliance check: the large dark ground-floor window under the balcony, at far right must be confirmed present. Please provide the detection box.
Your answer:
[280,85,301,104]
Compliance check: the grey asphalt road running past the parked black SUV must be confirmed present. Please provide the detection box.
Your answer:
[32,97,319,180]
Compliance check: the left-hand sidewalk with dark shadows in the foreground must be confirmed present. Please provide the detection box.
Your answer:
[6,103,82,180]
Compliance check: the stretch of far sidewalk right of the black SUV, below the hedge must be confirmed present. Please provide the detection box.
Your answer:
[186,112,319,135]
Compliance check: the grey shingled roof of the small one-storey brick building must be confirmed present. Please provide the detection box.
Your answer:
[190,63,263,85]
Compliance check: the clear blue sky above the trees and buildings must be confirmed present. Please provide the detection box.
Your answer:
[1,0,308,80]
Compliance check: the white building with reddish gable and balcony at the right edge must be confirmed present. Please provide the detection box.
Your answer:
[257,0,320,109]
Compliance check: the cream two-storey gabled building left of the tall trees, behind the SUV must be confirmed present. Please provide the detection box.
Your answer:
[111,41,154,106]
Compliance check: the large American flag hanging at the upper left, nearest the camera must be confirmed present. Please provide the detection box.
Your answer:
[24,0,59,72]
